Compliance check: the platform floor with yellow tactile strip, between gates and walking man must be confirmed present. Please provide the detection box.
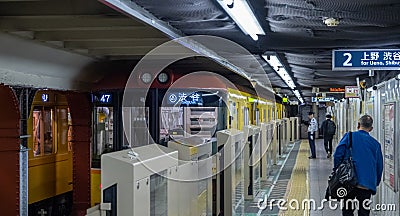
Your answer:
[252,139,346,216]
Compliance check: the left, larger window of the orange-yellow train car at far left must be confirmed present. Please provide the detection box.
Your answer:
[32,107,54,157]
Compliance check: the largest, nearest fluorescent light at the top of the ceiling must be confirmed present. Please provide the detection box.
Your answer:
[217,0,265,40]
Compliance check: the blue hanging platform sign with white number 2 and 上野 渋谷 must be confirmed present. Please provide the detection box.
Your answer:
[332,49,400,70]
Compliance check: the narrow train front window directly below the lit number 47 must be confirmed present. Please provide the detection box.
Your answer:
[92,107,114,168]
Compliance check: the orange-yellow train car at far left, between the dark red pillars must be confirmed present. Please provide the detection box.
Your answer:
[28,91,73,215]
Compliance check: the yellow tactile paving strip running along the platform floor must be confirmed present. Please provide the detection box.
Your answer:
[279,140,310,216]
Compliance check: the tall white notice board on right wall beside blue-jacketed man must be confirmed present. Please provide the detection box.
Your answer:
[383,103,397,191]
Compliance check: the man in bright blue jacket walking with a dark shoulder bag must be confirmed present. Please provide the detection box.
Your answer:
[334,115,383,216]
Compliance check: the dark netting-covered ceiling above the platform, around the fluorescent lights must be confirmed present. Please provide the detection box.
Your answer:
[127,0,400,100]
